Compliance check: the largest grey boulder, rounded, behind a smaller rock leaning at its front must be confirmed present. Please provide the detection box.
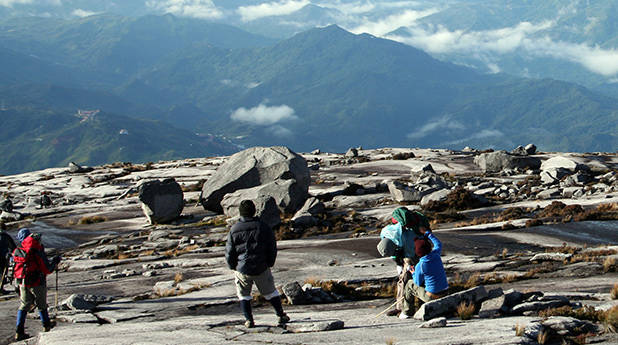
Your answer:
[200,146,311,213]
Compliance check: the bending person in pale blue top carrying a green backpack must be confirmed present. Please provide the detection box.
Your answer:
[378,206,431,316]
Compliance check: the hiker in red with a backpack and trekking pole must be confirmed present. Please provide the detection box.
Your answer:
[13,228,60,340]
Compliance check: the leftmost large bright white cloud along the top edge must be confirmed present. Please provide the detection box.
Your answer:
[146,0,223,19]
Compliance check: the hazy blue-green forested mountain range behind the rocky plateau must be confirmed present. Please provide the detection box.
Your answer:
[0,15,618,173]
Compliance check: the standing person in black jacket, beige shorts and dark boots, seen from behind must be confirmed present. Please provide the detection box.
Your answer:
[225,200,290,328]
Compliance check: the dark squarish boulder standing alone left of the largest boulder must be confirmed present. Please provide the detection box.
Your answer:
[138,178,184,224]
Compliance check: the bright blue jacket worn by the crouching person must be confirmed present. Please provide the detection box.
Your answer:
[413,232,448,294]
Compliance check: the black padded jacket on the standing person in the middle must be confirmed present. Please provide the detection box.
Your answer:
[225,217,277,275]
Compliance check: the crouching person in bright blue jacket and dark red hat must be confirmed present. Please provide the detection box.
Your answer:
[399,227,448,319]
